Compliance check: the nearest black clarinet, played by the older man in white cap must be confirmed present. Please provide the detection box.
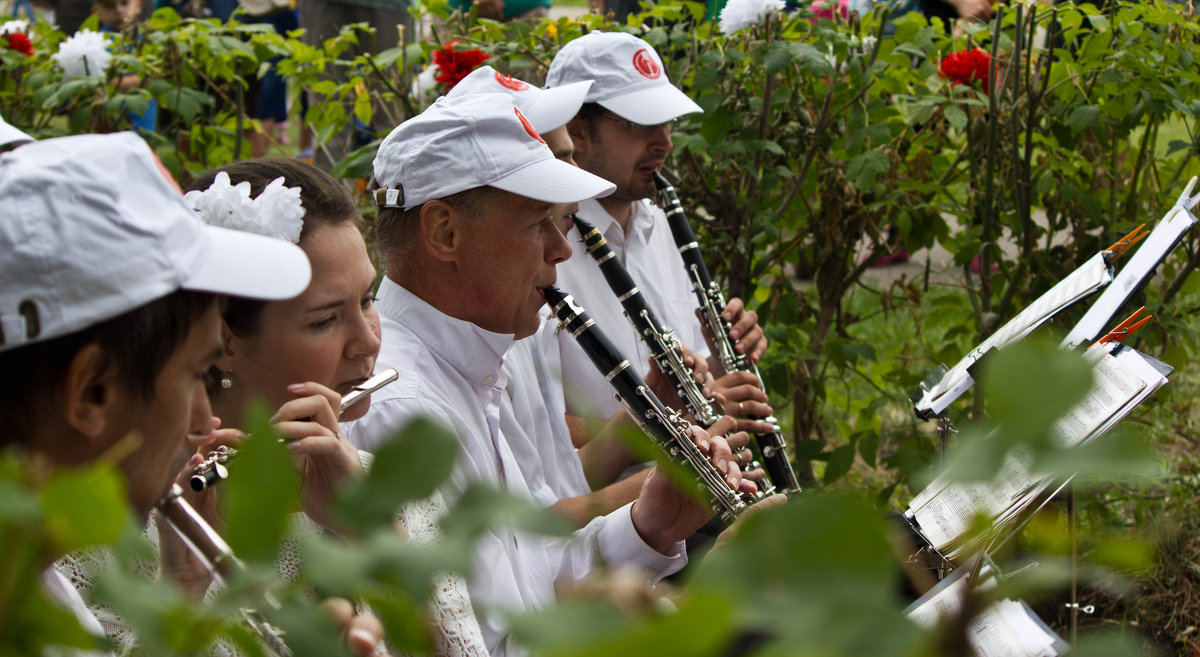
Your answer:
[545,287,746,522]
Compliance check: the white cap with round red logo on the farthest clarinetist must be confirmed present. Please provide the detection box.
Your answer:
[546,32,703,126]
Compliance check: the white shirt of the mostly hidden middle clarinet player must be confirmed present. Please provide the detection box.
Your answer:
[500,314,592,506]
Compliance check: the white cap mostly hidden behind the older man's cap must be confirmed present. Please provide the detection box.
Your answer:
[446,66,592,133]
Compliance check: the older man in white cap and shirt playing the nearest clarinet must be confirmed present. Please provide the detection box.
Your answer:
[347,94,755,655]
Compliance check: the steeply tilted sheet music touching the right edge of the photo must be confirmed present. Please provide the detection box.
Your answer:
[1062,179,1196,349]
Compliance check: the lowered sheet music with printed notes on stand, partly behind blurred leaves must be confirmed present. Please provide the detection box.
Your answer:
[907,343,1169,551]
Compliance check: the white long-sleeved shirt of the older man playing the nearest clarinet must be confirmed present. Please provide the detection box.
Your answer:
[347,278,688,655]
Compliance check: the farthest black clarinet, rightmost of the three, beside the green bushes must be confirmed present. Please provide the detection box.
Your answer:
[654,171,800,493]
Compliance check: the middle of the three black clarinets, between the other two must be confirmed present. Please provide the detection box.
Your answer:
[571,215,721,428]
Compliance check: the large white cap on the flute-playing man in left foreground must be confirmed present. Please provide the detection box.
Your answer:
[0,132,312,351]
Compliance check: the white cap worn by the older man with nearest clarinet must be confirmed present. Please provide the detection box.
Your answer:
[374,94,616,210]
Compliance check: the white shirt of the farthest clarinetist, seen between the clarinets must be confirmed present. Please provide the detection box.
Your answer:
[557,199,709,418]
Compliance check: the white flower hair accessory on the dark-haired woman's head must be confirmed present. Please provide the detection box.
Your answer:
[184,171,304,243]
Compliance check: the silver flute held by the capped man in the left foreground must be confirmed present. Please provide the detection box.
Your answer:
[158,483,293,657]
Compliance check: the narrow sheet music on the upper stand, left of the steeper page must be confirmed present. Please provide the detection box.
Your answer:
[916,252,1112,415]
